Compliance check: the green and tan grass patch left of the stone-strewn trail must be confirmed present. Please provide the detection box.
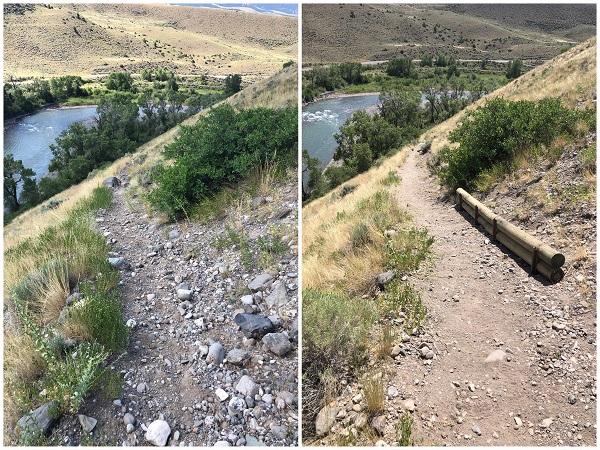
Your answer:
[4,187,127,440]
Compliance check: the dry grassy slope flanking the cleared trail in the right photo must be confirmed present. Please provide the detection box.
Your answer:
[302,38,596,445]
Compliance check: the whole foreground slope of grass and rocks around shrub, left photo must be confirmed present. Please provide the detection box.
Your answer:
[4,67,298,446]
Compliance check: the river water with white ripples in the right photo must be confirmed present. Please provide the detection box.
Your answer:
[302,94,379,167]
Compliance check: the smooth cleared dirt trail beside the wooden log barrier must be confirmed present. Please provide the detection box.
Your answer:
[384,150,596,445]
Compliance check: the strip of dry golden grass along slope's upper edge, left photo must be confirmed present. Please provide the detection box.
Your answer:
[4,66,298,248]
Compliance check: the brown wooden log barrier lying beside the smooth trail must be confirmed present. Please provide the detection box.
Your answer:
[456,188,565,283]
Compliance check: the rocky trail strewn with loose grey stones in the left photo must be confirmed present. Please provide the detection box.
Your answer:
[58,173,298,446]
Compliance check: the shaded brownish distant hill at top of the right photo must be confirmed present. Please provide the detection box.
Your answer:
[302,4,596,63]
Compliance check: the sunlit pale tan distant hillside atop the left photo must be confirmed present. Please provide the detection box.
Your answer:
[4,4,297,79]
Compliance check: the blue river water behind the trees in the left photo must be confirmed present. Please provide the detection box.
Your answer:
[4,106,96,180]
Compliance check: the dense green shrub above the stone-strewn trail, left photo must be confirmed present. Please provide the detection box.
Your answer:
[148,105,298,218]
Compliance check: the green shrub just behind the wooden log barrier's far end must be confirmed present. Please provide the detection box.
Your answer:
[440,98,578,189]
